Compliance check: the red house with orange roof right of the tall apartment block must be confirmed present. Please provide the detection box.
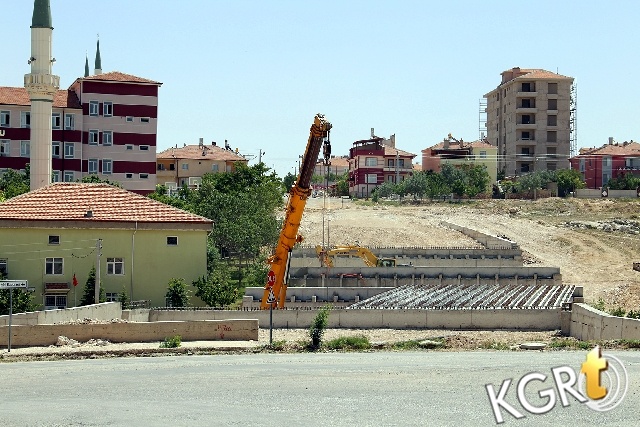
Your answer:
[570,138,640,189]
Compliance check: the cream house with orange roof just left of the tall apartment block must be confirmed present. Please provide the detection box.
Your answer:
[422,134,498,183]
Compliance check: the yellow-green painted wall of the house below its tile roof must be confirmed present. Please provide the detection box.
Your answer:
[0,228,207,307]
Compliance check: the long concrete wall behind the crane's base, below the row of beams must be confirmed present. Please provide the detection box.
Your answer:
[149,309,561,331]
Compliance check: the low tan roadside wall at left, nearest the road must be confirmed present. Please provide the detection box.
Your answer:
[0,320,258,347]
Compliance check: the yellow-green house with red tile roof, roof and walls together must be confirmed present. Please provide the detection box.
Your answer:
[0,183,213,309]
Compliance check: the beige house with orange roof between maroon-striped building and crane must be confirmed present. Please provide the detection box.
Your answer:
[156,138,248,190]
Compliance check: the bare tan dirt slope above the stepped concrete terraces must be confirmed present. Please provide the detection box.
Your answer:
[300,198,640,310]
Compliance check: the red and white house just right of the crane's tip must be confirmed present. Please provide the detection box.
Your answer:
[349,133,416,197]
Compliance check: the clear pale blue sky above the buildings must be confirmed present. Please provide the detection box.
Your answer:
[0,0,640,177]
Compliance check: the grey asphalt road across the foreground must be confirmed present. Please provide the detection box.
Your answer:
[0,351,640,427]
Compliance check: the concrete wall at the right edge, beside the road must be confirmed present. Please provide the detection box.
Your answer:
[562,304,640,341]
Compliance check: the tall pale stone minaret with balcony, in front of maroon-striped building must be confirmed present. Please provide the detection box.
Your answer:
[24,0,60,191]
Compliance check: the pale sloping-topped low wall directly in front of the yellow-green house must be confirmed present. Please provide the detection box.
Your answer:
[0,302,122,326]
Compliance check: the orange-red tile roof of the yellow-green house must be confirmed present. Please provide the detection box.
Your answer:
[0,182,213,225]
